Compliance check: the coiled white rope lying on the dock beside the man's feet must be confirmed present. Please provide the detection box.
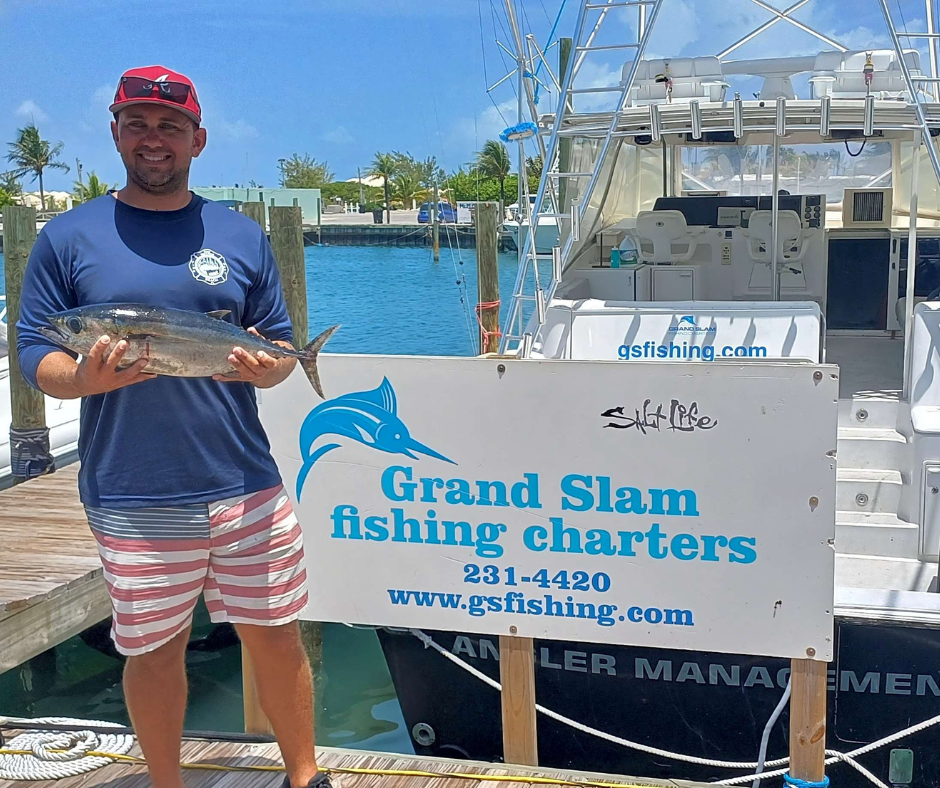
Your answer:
[0,717,134,780]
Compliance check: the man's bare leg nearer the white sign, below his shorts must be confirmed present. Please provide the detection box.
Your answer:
[235,621,317,788]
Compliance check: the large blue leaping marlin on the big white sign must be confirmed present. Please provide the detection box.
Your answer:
[297,378,457,501]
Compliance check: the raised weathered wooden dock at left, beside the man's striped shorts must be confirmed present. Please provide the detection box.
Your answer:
[0,463,111,673]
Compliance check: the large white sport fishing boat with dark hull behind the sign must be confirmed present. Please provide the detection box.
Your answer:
[379,0,940,788]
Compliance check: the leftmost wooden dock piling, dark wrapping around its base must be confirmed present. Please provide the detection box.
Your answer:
[3,205,55,483]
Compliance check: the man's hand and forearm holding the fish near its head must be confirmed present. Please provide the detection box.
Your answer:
[36,336,156,399]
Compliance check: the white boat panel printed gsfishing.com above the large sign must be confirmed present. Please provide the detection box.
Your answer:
[536,300,822,362]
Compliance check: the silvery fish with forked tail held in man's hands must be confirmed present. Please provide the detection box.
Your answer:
[39,303,339,399]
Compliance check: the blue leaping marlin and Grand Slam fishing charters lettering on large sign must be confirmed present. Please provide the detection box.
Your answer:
[297,379,758,565]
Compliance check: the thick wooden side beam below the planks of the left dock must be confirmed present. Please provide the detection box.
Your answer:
[0,574,111,673]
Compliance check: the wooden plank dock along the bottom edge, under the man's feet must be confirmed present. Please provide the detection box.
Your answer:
[0,741,705,788]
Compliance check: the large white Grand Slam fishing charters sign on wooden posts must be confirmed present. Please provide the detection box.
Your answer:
[261,355,838,660]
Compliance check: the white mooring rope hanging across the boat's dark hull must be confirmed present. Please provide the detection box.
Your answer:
[409,629,940,788]
